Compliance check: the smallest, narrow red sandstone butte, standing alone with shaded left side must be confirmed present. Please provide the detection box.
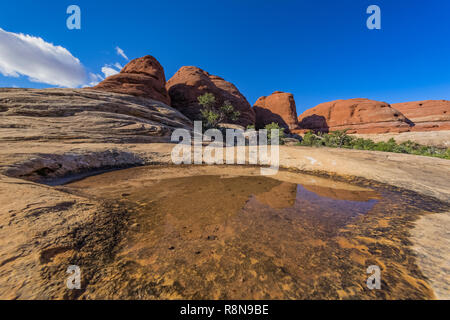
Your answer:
[253,91,298,130]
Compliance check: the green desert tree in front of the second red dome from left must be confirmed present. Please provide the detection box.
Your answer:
[197,93,241,130]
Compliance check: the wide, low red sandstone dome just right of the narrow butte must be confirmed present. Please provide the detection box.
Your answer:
[298,99,413,133]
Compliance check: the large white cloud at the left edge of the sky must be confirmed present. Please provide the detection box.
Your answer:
[0,28,87,87]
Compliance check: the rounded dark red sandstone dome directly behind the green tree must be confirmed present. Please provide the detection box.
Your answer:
[166,67,255,127]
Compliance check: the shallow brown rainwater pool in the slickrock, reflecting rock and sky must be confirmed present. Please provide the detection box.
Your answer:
[64,168,450,299]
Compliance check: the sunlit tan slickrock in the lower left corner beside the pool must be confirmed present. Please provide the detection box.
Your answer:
[0,175,100,299]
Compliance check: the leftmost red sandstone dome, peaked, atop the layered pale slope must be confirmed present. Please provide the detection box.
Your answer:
[92,56,170,106]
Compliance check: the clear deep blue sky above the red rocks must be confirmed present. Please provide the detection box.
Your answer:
[0,0,450,113]
